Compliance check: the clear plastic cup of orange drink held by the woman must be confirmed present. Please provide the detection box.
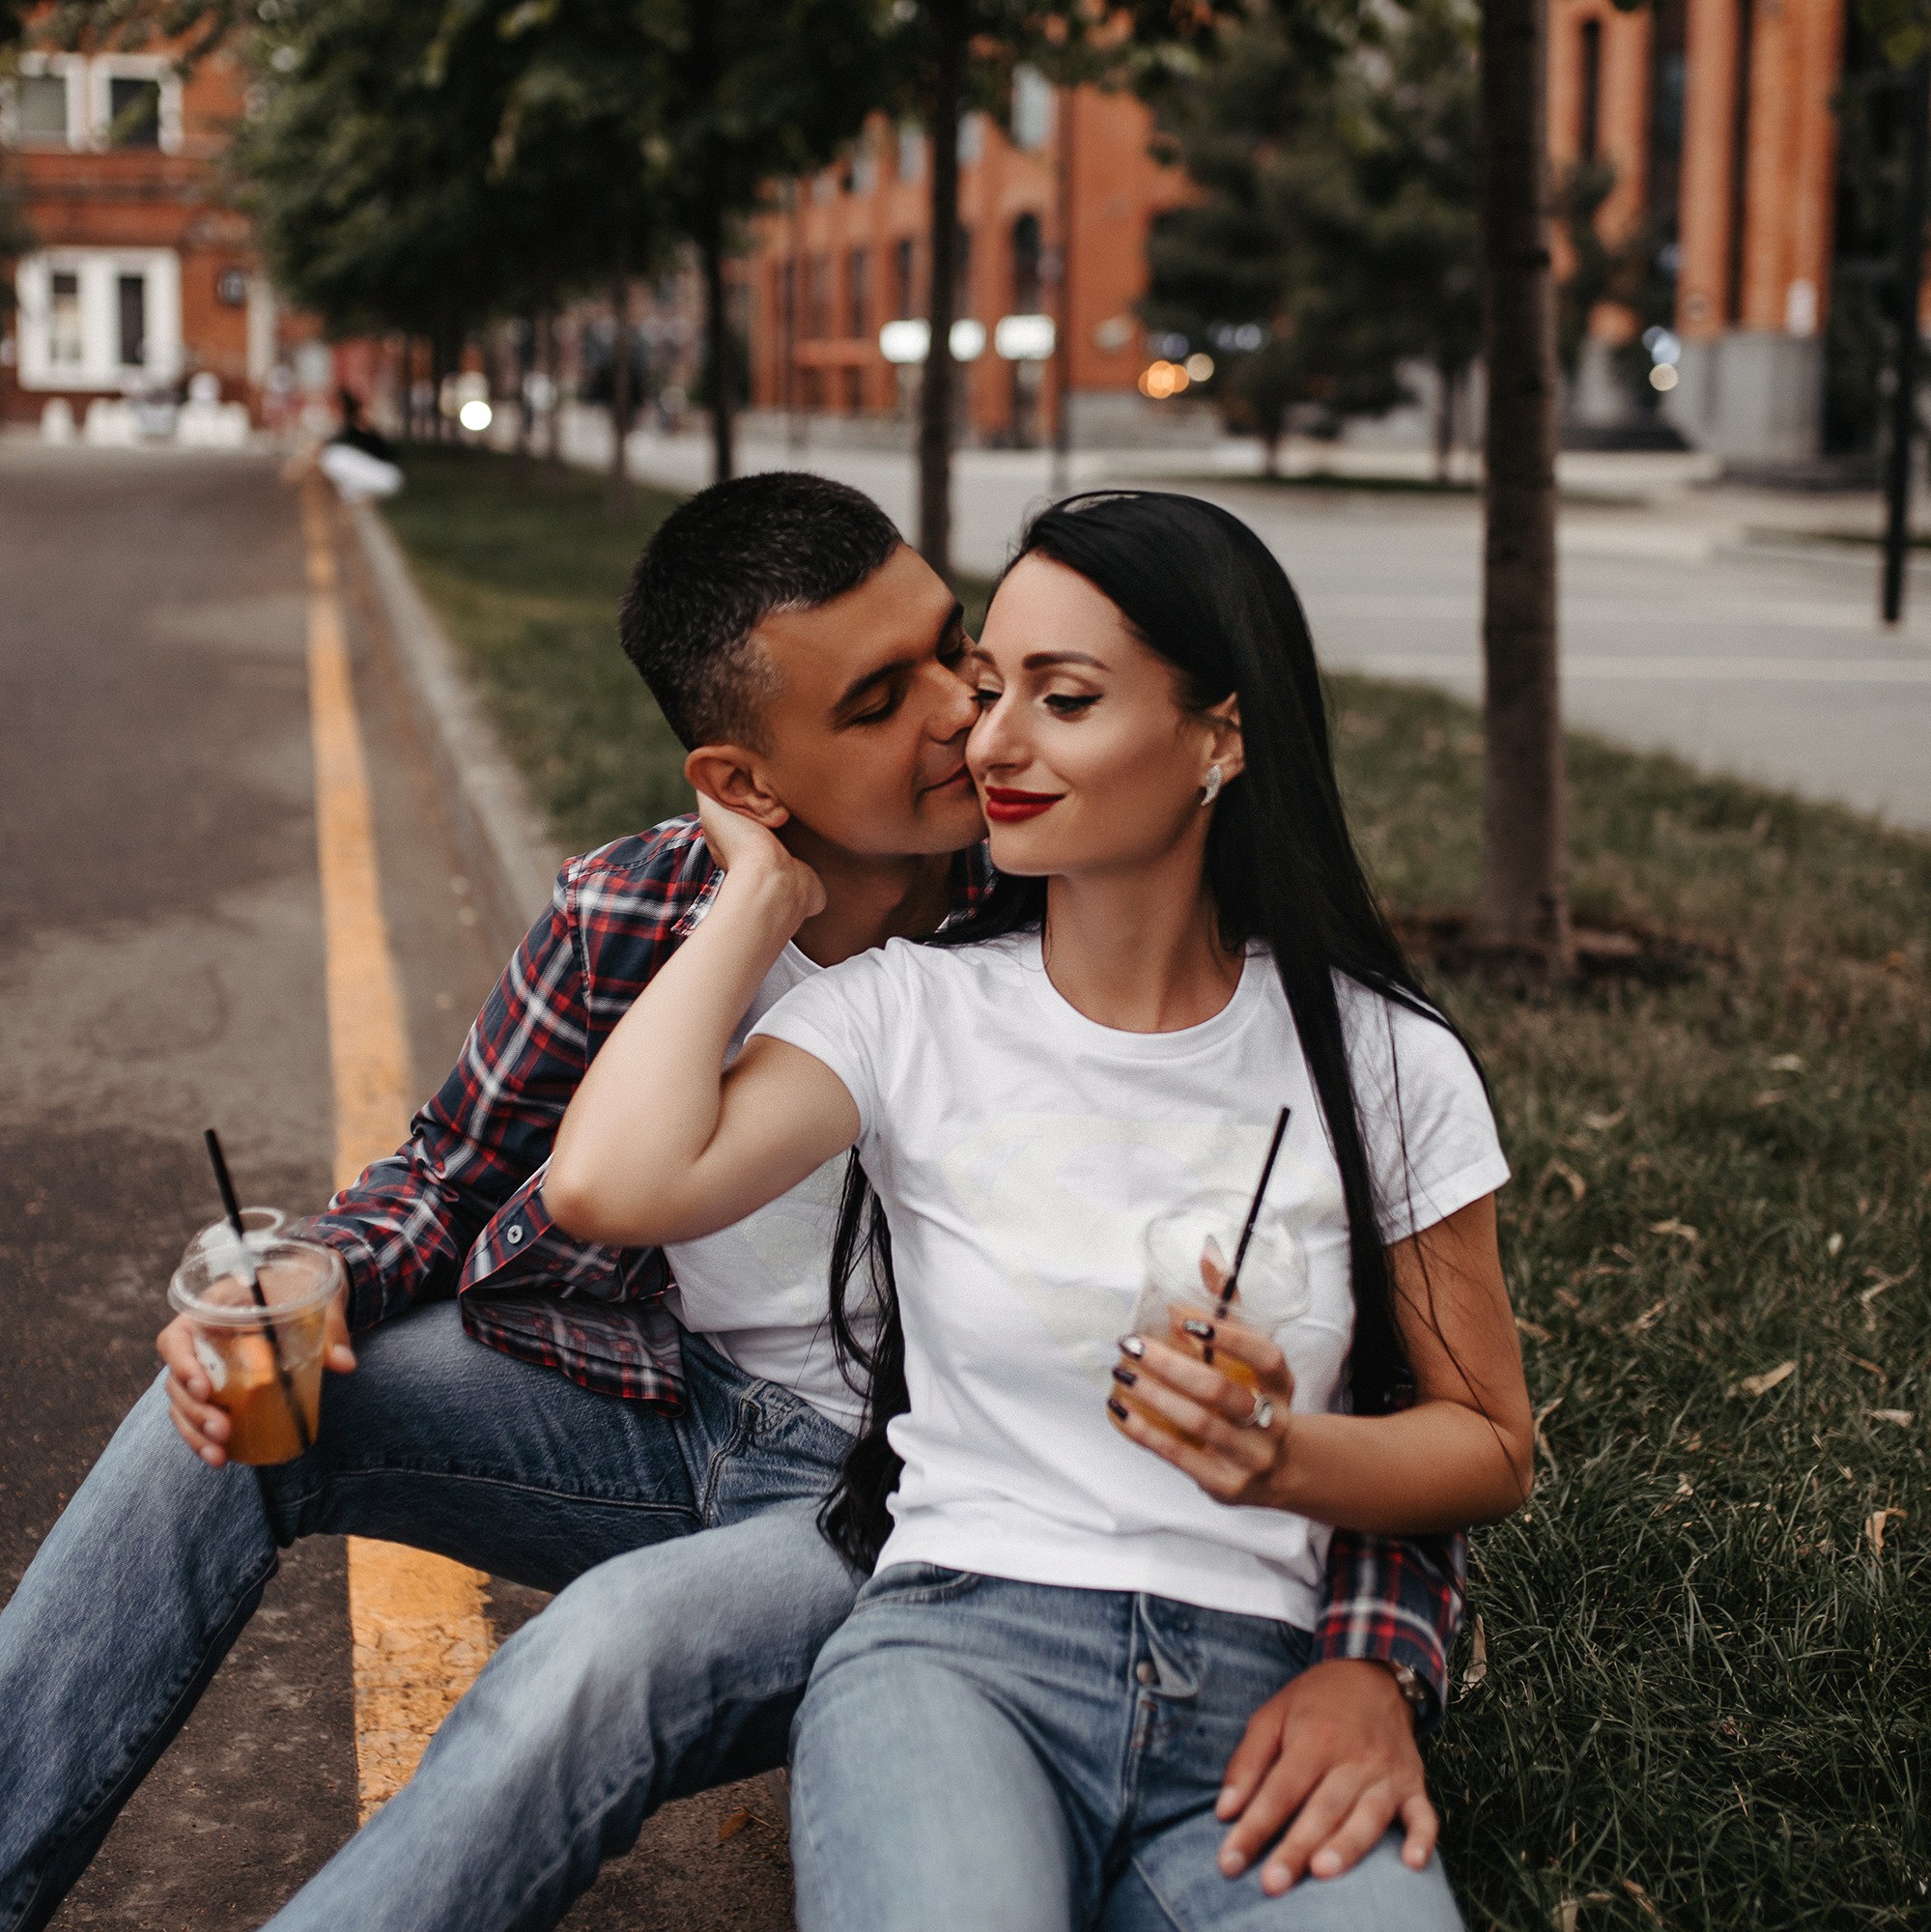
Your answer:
[1120,1192,1309,1439]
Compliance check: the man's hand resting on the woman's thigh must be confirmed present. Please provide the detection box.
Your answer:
[1214,1660,1440,1897]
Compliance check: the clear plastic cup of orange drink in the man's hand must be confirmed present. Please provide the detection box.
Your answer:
[168,1208,348,1468]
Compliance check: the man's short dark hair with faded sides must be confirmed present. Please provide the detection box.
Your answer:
[618,469,900,750]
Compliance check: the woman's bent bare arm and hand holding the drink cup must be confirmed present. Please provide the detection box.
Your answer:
[1112,1194,1535,1536]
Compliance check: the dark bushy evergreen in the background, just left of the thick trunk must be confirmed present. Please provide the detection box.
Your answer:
[1143,0,1481,471]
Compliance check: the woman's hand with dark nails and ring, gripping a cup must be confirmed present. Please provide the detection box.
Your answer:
[1106,1314,1293,1507]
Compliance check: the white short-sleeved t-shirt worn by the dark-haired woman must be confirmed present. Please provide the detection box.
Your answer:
[753,933,1508,1627]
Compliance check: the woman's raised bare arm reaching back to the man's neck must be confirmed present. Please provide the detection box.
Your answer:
[543,806,860,1248]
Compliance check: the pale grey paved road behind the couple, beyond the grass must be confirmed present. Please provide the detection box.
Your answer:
[613,435,1931,831]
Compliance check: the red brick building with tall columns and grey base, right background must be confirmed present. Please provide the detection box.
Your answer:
[1548,0,1906,466]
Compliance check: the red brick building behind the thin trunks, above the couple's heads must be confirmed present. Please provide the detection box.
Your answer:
[744,71,1185,446]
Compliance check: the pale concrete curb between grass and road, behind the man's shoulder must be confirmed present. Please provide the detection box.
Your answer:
[344,502,564,956]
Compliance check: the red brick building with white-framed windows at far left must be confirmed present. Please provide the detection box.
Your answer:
[0,33,276,419]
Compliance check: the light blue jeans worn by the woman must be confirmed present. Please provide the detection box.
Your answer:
[792,1563,1462,1932]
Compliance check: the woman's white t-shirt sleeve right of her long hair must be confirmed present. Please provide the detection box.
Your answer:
[1342,985,1508,1244]
